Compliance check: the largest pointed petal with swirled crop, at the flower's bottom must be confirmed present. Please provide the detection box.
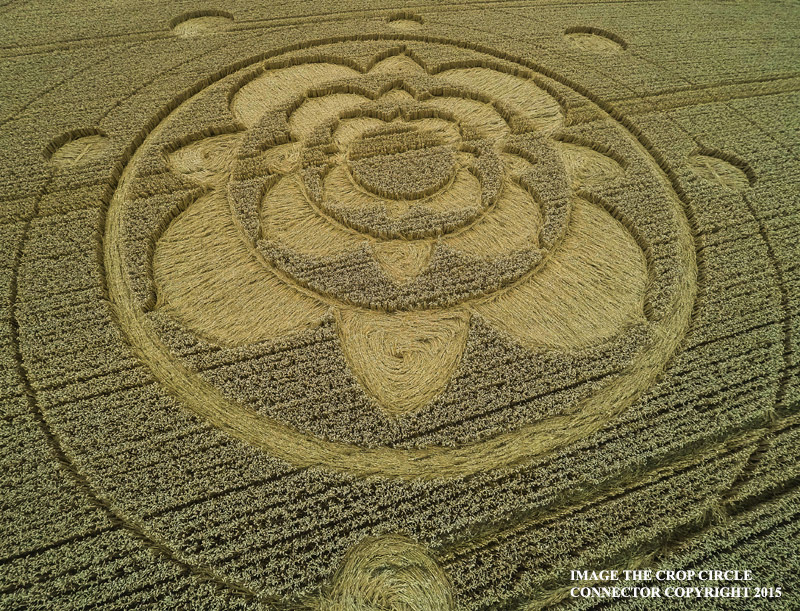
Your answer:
[336,309,469,416]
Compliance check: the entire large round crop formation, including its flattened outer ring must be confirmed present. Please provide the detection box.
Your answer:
[105,40,696,477]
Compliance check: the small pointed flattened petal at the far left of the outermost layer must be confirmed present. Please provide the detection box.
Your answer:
[167,132,244,187]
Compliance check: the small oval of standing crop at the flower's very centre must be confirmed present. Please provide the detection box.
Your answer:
[347,126,457,200]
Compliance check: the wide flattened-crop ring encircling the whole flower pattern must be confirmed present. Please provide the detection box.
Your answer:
[104,37,697,479]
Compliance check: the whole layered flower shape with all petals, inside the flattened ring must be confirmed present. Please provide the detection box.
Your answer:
[155,54,647,415]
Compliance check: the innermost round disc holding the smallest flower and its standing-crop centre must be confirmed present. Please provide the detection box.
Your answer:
[310,111,502,247]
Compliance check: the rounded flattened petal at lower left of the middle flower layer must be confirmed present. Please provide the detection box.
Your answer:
[261,175,366,257]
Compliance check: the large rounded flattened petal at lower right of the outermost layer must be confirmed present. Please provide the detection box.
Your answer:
[473,199,648,349]
